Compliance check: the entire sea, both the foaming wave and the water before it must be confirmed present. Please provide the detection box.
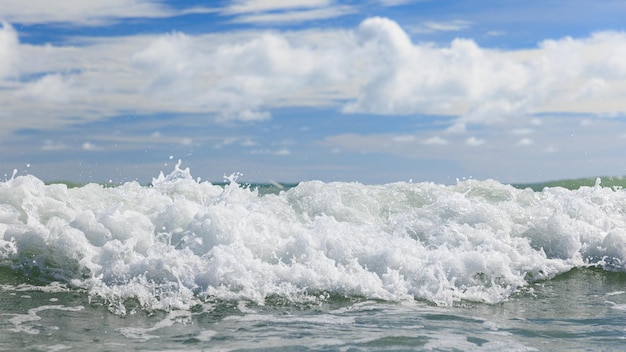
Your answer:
[0,166,626,351]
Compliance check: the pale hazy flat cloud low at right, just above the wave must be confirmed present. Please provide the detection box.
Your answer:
[323,115,626,182]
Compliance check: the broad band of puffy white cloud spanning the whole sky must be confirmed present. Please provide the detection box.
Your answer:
[0,16,626,138]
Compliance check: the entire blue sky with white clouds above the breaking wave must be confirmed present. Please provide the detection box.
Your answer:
[0,0,626,184]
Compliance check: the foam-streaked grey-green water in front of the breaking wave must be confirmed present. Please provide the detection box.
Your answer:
[0,269,626,351]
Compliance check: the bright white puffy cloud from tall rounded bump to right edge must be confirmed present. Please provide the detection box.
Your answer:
[344,18,626,123]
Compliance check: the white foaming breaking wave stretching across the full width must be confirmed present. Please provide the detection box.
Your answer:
[0,166,626,312]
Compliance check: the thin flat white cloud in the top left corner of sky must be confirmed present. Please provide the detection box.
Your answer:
[0,0,215,26]
